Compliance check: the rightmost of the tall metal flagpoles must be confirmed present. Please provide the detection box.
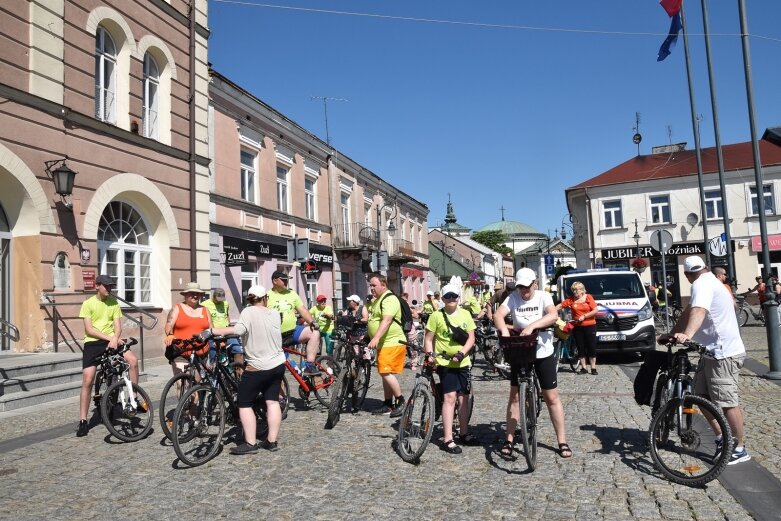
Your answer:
[738,0,781,380]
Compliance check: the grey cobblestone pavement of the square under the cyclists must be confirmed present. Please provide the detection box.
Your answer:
[0,328,781,521]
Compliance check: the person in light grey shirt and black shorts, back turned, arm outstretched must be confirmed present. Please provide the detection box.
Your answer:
[201,285,285,455]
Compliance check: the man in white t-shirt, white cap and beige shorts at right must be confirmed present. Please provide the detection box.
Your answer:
[659,256,751,465]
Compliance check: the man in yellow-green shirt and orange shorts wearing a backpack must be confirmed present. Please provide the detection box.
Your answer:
[368,273,407,418]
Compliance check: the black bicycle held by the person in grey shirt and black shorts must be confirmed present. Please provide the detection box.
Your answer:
[172,337,287,467]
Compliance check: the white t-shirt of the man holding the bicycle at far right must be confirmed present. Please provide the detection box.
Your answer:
[689,272,746,359]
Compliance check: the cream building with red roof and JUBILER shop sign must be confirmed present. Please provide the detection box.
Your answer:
[566,135,781,301]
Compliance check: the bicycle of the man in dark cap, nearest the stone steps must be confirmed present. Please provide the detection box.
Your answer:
[92,338,154,442]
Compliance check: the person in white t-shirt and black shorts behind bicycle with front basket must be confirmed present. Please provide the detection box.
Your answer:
[494,268,572,458]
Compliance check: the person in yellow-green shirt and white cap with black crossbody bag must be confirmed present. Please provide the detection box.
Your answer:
[423,284,479,454]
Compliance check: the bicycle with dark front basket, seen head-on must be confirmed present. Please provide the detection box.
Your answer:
[499,331,542,471]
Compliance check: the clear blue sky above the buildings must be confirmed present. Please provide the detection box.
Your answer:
[209,0,781,233]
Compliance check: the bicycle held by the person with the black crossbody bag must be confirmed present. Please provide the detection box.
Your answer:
[394,341,475,463]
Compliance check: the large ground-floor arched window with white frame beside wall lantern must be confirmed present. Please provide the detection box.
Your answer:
[98,201,152,305]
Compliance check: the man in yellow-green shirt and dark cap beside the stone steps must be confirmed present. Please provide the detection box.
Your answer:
[76,275,138,437]
